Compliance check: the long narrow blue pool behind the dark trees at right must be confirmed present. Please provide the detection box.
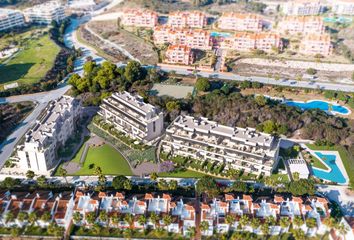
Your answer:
[285,101,349,114]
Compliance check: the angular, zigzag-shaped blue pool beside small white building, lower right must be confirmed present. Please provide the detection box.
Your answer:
[312,152,346,184]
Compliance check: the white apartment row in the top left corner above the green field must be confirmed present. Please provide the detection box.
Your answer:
[0,1,66,31]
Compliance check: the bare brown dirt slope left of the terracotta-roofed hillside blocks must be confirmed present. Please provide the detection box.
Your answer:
[89,21,159,64]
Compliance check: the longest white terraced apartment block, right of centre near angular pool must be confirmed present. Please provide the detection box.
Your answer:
[162,115,279,176]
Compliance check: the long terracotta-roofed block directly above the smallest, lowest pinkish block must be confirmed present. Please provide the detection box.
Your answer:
[154,26,212,50]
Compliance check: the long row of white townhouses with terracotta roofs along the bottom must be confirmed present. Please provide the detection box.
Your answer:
[0,190,342,238]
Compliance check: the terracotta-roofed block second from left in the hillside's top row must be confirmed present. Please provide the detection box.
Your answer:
[167,11,207,28]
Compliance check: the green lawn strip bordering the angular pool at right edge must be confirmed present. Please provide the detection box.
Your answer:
[306,144,354,187]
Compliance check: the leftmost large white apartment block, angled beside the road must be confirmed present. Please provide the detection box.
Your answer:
[17,96,81,174]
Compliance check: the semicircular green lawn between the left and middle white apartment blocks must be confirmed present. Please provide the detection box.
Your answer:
[72,144,133,175]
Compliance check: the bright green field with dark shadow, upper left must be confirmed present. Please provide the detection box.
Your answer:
[0,34,60,85]
